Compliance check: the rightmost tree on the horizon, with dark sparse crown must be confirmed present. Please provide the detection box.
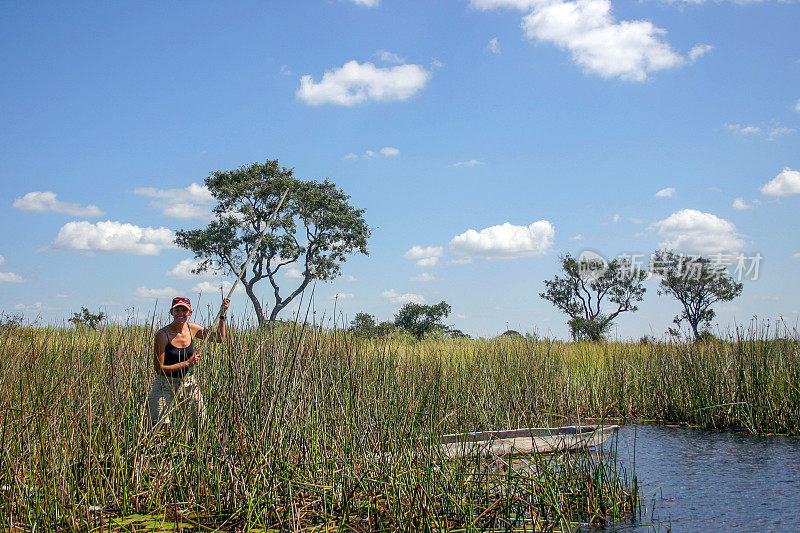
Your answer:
[652,250,743,341]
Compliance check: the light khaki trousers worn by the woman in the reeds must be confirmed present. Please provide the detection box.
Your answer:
[147,372,206,427]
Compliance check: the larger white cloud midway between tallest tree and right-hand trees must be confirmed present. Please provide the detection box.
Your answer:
[450,220,556,259]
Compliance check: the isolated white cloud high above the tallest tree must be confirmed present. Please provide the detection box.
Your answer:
[297,61,431,106]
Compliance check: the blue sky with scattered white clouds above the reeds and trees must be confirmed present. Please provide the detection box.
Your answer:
[0,0,800,338]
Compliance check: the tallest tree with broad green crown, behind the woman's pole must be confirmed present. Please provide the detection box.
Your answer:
[175,160,370,325]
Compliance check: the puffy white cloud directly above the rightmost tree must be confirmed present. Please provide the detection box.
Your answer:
[653,209,745,254]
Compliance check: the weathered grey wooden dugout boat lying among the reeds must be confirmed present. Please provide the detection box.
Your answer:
[439,425,619,457]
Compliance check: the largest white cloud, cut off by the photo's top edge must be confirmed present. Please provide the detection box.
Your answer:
[470,0,697,81]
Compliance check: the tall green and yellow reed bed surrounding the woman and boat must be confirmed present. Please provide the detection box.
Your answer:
[0,318,800,531]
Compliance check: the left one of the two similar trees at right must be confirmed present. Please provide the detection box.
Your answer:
[539,254,647,341]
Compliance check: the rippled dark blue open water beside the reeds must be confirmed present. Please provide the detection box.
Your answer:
[610,425,800,533]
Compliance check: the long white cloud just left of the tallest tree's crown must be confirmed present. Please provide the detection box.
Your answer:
[52,220,176,255]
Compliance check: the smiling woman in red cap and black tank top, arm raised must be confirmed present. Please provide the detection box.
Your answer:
[147,296,230,426]
